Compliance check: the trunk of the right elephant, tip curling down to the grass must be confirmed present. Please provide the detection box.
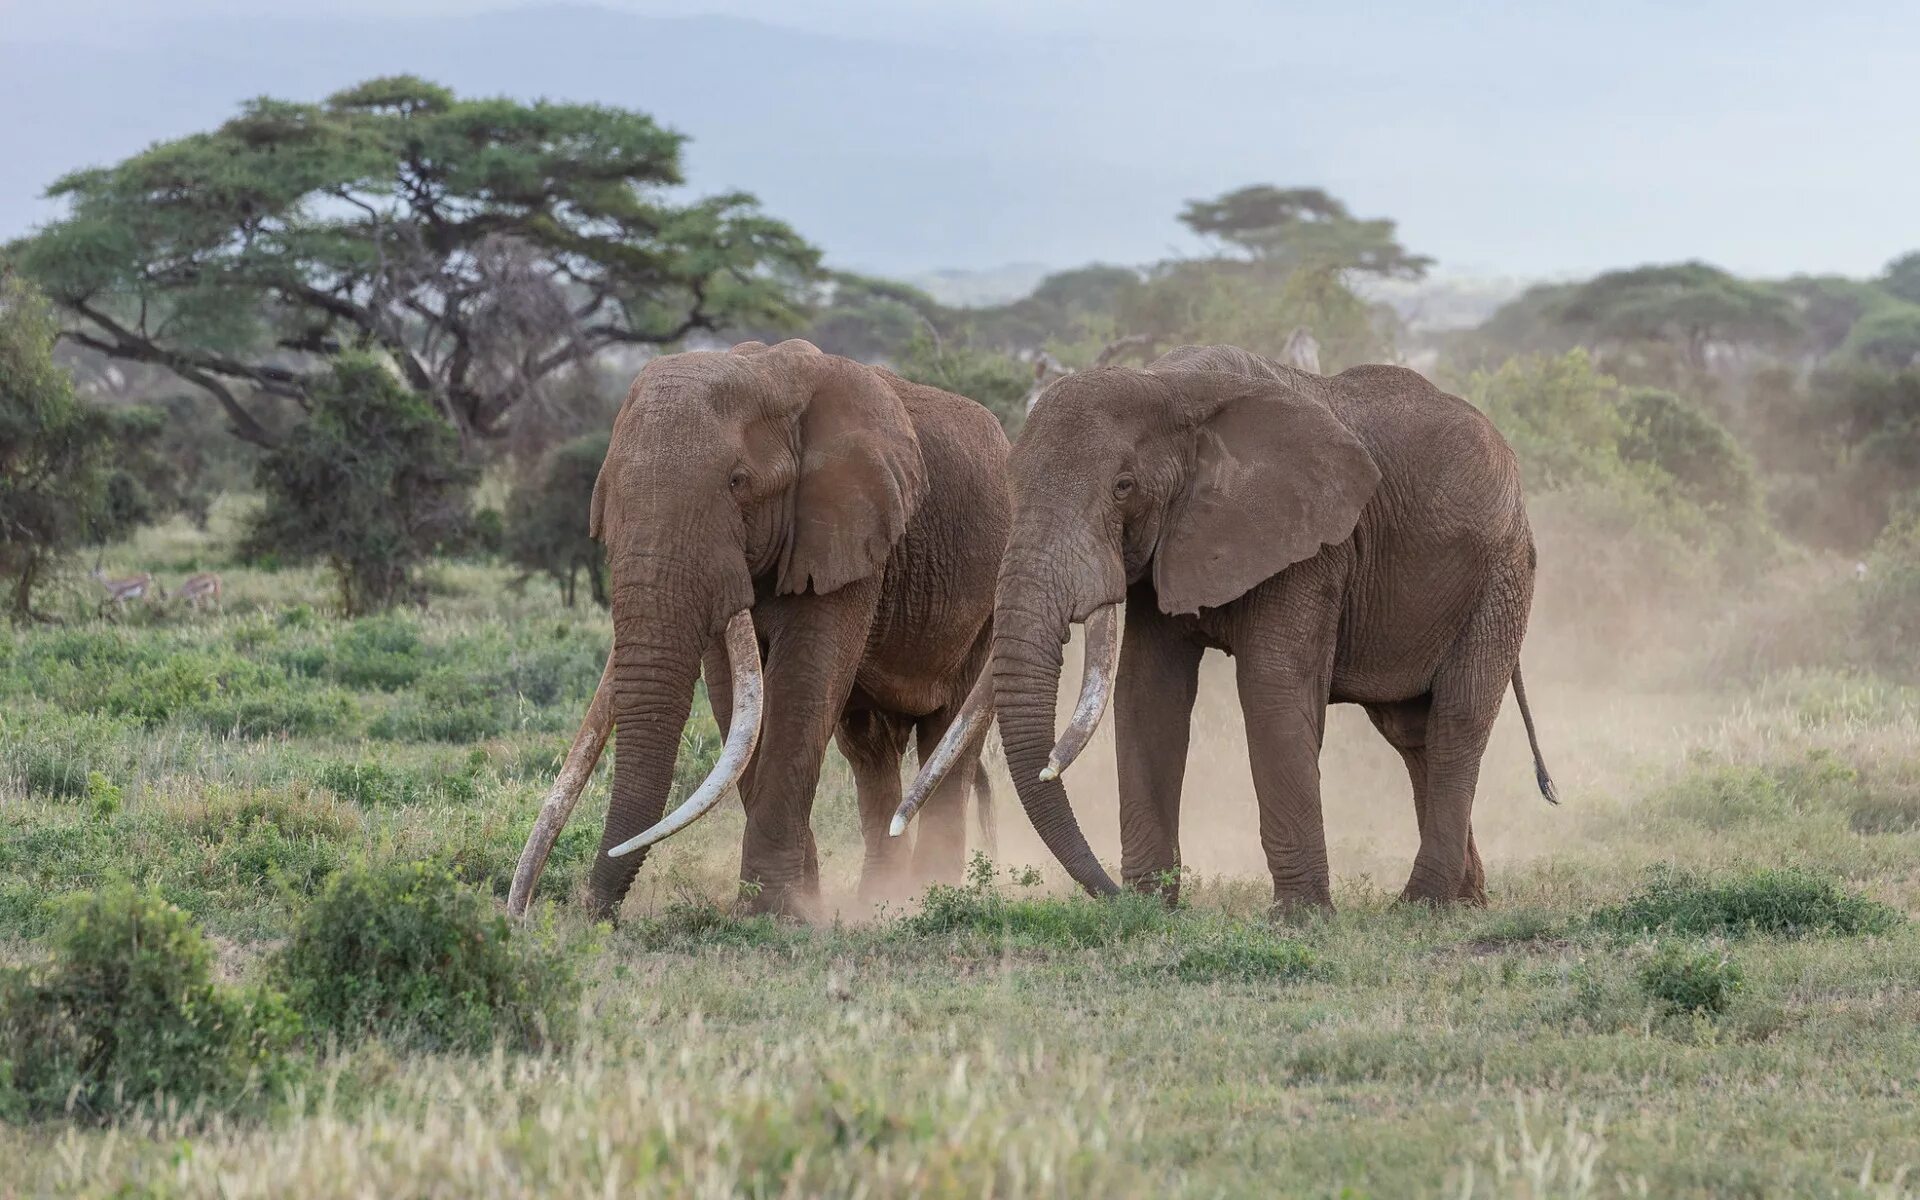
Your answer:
[993,576,1119,895]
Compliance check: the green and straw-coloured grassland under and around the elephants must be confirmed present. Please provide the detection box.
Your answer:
[0,513,1920,1196]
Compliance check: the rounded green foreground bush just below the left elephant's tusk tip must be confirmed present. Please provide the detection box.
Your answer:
[280,862,580,1050]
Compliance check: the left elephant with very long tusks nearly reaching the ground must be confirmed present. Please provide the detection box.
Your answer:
[509,340,1012,918]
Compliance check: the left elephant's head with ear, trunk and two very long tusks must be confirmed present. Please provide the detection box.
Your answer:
[509,342,925,910]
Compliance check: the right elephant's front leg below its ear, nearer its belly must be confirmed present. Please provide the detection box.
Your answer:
[1235,568,1340,914]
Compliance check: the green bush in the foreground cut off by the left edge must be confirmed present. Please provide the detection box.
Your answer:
[0,883,300,1119]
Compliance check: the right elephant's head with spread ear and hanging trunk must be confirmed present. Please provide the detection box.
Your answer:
[916,348,1380,893]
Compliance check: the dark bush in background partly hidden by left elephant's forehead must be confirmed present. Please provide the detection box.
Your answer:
[505,434,611,609]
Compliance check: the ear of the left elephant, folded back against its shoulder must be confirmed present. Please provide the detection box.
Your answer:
[774,357,927,593]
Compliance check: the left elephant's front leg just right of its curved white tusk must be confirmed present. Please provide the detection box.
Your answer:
[739,578,879,918]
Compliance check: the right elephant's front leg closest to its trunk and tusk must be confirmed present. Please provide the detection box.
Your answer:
[1114,582,1206,904]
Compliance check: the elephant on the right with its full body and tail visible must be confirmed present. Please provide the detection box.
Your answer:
[893,346,1559,914]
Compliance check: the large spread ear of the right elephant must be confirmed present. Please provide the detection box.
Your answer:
[1154,371,1380,614]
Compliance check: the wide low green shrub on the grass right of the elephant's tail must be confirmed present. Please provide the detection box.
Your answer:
[1594,866,1905,937]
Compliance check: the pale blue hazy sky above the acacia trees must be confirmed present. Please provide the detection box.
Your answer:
[0,0,1920,275]
